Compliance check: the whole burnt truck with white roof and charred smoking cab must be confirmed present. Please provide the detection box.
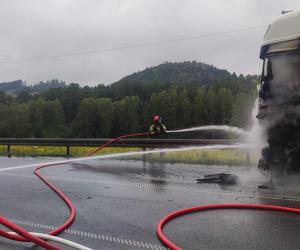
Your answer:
[257,11,300,174]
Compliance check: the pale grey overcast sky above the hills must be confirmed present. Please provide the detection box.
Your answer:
[0,0,300,86]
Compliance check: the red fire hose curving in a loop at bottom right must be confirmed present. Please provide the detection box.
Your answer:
[156,204,300,250]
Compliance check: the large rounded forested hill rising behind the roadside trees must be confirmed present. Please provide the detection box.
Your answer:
[109,61,259,97]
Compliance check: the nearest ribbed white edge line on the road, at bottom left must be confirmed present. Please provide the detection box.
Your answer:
[9,218,167,250]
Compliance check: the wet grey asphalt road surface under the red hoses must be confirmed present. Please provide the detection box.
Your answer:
[0,155,300,250]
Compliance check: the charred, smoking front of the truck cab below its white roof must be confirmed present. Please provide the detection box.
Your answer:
[259,53,300,174]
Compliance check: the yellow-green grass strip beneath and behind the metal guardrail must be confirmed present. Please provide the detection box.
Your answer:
[0,146,259,165]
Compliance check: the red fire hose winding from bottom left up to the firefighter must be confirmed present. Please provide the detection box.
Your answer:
[0,132,148,250]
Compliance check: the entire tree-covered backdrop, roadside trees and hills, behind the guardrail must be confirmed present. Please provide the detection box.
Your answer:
[0,62,259,138]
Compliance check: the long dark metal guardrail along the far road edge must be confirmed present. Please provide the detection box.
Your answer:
[0,138,239,156]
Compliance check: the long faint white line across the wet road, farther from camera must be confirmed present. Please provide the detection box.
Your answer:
[0,173,300,201]
